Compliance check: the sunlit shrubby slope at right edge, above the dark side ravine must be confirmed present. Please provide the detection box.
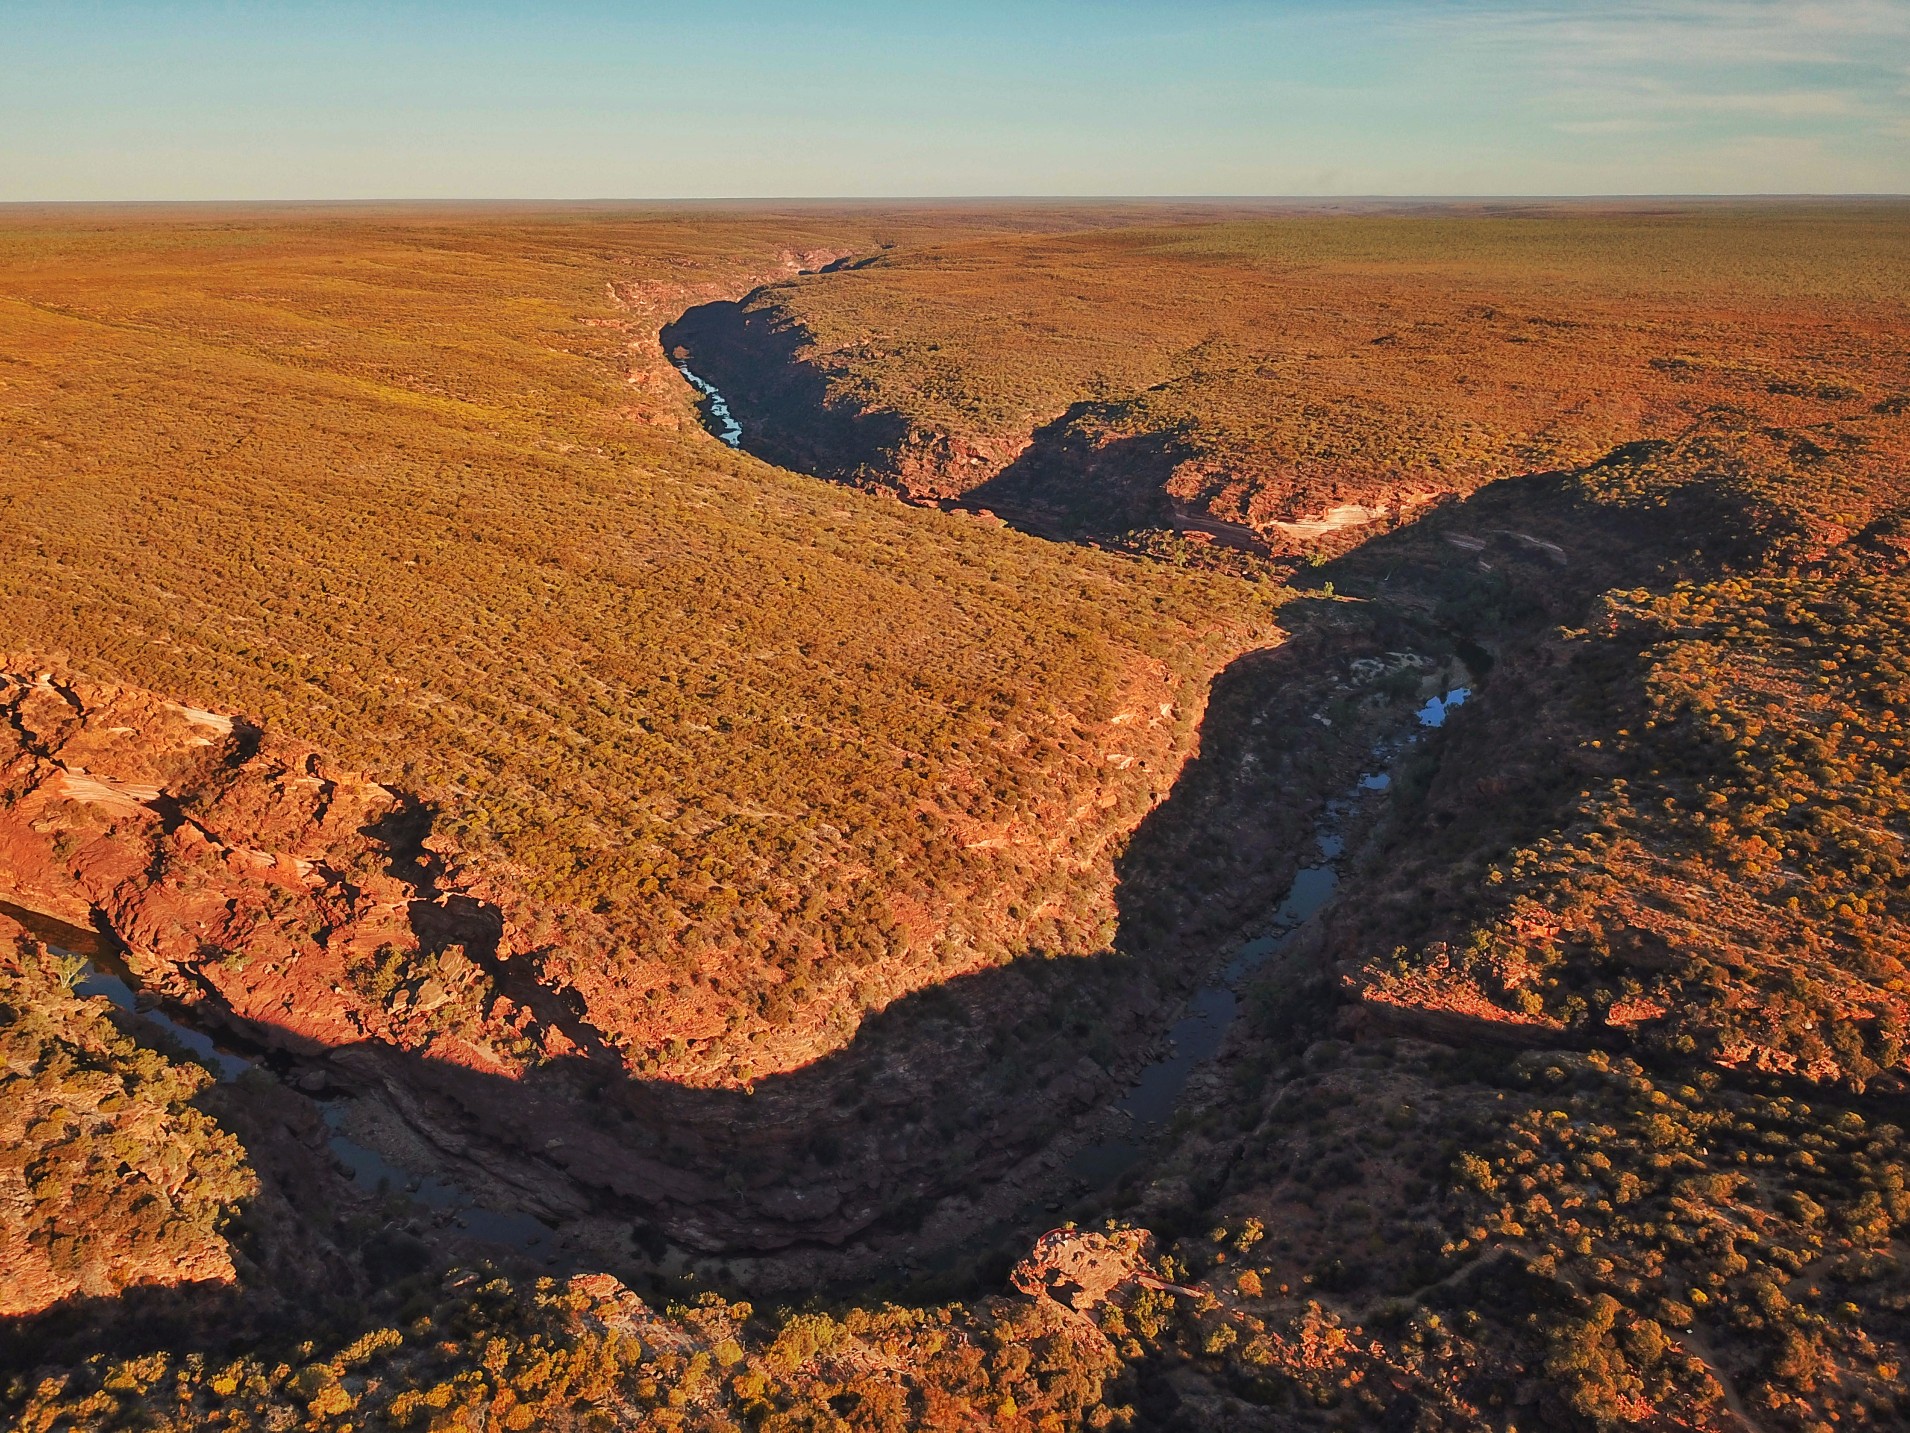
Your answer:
[1359,418,1910,1087]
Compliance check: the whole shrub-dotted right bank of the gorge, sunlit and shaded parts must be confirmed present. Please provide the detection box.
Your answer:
[1115,405,1910,1429]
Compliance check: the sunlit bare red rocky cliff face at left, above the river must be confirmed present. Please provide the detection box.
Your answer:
[0,671,550,1074]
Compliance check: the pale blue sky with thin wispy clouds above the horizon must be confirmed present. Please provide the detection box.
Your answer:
[0,0,1910,201]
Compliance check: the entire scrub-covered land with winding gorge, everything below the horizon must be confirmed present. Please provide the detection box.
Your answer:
[11,203,1910,1427]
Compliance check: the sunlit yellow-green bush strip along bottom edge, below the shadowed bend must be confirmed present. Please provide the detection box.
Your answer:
[10,1271,1133,1433]
